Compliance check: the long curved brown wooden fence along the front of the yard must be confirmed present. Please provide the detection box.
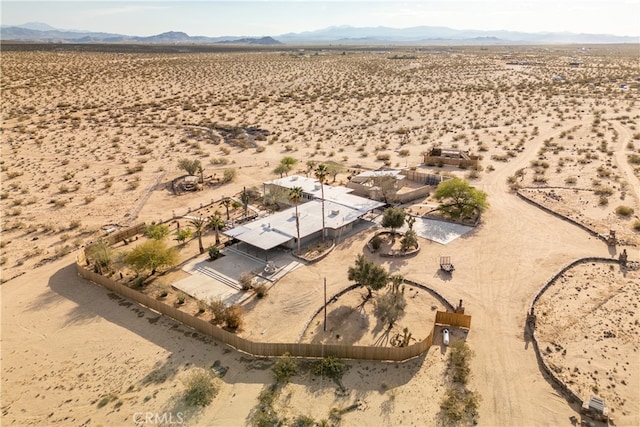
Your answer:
[76,251,471,361]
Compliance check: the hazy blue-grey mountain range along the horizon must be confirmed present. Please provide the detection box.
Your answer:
[0,22,640,45]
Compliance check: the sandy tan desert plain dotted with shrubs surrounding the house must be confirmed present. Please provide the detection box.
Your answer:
[0,43,640,426]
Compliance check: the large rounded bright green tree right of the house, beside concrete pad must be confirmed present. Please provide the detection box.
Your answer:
[433,178,489,219]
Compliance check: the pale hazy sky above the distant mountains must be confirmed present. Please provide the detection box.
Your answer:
[0,0,640,37]
